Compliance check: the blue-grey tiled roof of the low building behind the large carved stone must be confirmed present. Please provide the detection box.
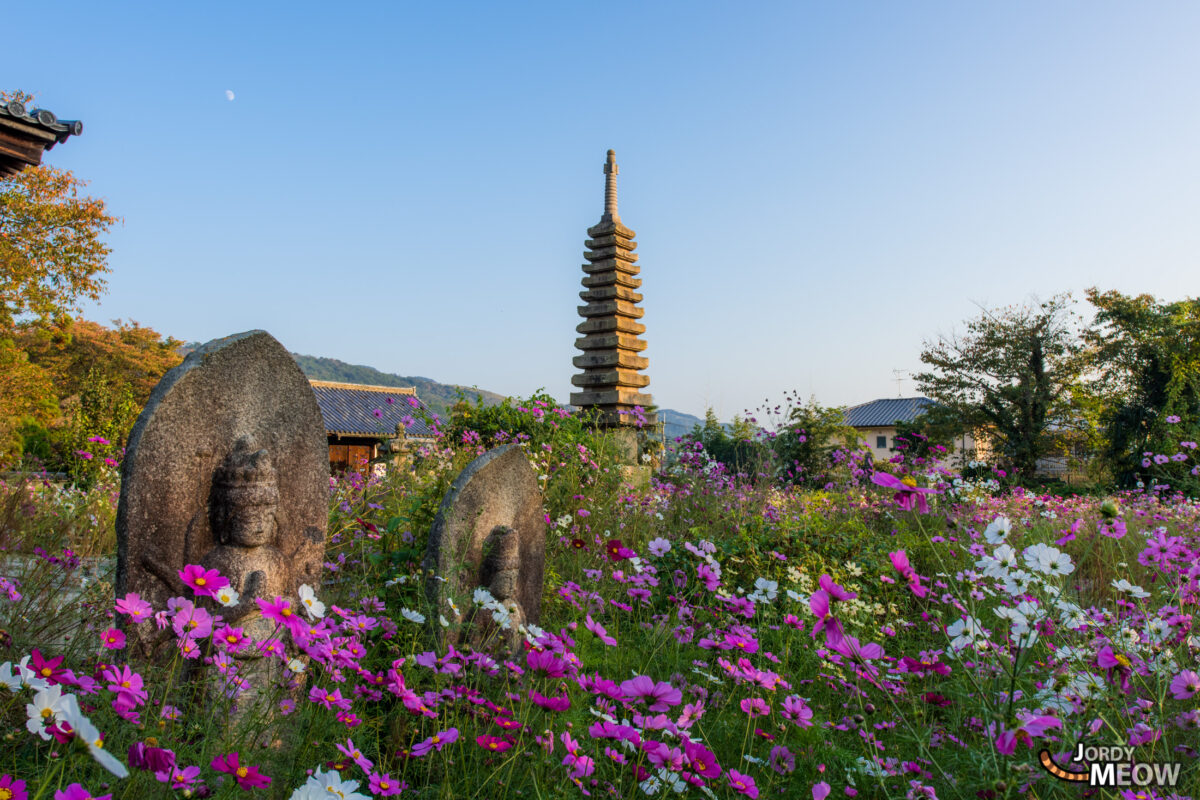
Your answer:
[308,380,433,439]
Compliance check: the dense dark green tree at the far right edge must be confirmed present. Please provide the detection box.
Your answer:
[1086,288,1200,493]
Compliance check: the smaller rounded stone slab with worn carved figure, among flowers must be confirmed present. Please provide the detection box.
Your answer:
[422,444,546,649]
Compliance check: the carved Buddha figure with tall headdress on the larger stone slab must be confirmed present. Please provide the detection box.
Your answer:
[200,437,292,621]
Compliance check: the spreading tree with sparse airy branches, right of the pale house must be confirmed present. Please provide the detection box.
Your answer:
[916,295,1086,480]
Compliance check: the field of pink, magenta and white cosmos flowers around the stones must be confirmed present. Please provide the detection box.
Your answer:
[0,407,1200,800]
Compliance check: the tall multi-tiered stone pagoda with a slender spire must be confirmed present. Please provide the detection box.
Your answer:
[571,150,655,427]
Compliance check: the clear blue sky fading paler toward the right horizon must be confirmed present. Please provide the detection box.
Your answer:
[9,2,1200,419]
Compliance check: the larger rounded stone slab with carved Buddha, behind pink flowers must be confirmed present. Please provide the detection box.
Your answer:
[116,331,329,658]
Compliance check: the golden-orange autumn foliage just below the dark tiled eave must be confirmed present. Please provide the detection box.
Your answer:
[0,92,118,336]
